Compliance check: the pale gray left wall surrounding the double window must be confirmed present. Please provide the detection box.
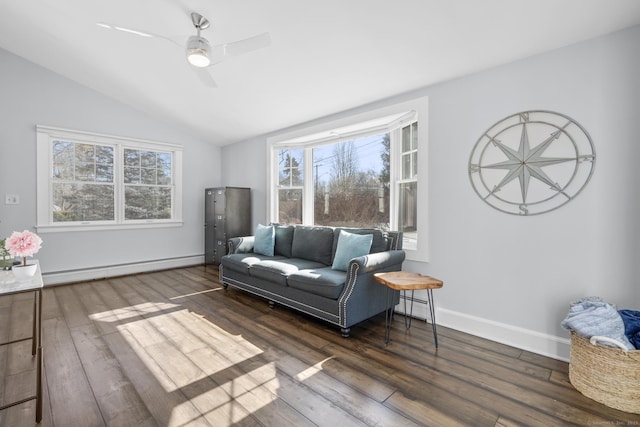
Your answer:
[0,46,221,273]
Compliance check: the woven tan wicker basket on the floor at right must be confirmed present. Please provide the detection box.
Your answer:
[569,332,640,414]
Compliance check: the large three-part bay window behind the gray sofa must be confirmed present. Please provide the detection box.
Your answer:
[269,96,427,260]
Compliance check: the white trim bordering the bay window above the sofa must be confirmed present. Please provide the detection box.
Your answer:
[266,97,429,262]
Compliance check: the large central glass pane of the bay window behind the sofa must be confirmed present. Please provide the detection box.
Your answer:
[313,134,389,228]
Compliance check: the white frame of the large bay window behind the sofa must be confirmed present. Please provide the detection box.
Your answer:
[266,97,429,262]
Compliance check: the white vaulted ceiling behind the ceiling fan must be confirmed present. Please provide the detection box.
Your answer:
[0,0,640,145]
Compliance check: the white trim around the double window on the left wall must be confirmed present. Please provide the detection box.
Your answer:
[36,125,183,233]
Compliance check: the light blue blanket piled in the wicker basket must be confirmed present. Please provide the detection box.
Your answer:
[560,297,635,350]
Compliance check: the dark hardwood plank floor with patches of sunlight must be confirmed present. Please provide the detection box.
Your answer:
[0,267,640,427]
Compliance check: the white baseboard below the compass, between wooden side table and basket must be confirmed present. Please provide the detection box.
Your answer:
[396,300,571,362]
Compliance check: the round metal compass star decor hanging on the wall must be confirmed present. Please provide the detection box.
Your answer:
[469,111,596,215]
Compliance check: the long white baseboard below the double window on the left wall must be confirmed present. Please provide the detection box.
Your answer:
[42,255,204,286]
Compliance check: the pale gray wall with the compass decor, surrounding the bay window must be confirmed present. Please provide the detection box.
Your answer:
[222,27,640,358]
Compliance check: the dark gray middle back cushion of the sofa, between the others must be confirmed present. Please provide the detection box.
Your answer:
[291,226,333,265]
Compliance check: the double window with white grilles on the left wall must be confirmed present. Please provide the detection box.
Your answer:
[37,126,182,231]
